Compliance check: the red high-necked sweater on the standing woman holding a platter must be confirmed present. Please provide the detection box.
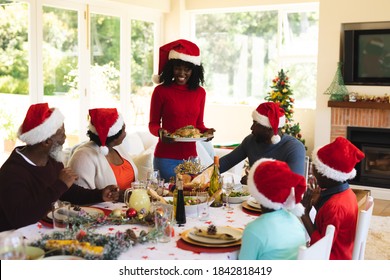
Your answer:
[149,84,207,160]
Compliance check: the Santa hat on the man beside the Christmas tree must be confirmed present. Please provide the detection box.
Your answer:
[252,102,286,144]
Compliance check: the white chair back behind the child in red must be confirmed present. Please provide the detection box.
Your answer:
[352,196,374,260]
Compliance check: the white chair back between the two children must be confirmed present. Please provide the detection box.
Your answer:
[297,225,336,260]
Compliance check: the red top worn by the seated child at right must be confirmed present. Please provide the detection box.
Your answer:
[310,189,358,260]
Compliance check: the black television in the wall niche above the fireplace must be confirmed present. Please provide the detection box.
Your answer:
[341,23,390,86]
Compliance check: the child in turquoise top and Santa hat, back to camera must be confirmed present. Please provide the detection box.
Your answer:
[239,158,306,260]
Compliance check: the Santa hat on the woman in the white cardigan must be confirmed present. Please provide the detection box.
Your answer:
[88,108,124,155]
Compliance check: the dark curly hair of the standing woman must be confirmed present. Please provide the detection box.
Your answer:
[160,59,204,90]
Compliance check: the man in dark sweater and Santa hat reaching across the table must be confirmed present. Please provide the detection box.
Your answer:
[219,102,306,184]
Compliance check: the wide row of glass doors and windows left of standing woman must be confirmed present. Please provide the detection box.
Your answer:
[0,0,162,149]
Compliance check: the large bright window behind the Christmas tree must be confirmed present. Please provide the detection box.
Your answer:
[192,4,318,108]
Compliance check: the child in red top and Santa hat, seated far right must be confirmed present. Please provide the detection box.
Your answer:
[302,137,365,260]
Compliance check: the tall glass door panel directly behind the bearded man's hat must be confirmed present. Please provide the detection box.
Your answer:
[42,6,80,147]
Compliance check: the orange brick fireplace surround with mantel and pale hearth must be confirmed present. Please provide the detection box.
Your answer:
[328,101,390,200]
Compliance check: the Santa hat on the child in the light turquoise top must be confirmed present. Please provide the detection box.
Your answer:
[248,158,306,217]
